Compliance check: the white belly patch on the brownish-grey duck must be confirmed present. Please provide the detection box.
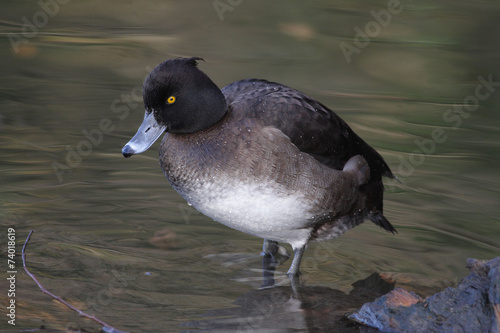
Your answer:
[178,179,314,247]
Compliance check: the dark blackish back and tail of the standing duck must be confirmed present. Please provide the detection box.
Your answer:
[222,79,395,232]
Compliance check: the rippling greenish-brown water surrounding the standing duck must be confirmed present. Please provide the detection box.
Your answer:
[0,1,500,332]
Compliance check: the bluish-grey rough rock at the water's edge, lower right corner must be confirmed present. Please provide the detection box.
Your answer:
[349,257,500,333]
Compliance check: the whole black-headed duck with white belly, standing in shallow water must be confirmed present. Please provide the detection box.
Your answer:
[122,57,396,278]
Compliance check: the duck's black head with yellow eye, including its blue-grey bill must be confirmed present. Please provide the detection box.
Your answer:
[122,58,227,157]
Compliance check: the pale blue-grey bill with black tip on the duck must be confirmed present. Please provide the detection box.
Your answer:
[122,112,167,157]
